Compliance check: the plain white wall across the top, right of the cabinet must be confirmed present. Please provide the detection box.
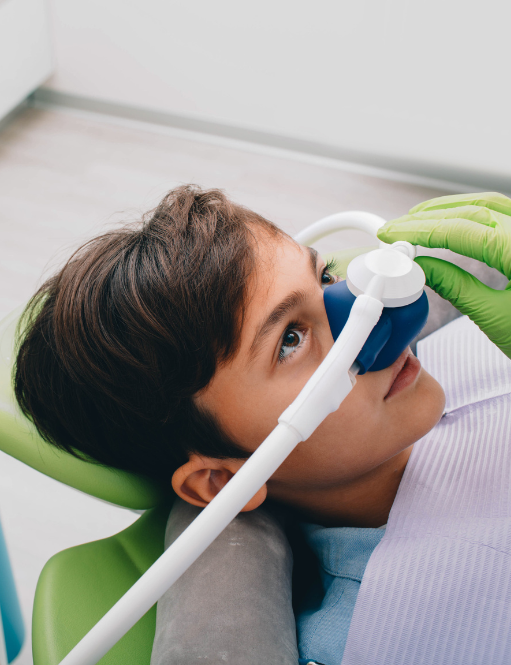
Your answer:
[48,0,511,183]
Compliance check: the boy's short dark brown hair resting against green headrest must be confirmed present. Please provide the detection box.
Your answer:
[15,186,280,482]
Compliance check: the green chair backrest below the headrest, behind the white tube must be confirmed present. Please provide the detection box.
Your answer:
[32,504,170,665]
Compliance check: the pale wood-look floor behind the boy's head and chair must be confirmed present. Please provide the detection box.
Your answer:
[0,109,448,665]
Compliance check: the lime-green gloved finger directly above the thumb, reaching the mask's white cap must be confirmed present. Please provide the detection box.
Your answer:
[378,215,511,279]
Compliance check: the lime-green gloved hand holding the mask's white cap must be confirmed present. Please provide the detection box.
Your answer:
[378,192,511,358]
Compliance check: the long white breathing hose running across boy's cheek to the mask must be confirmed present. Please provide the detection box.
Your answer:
[61,211,420,665]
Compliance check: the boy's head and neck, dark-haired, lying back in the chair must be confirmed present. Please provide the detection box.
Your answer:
[15,187,444,655]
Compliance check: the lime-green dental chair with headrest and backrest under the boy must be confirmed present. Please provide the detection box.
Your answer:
[0,247,373,665]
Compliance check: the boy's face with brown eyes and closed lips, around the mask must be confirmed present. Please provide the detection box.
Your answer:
[197,234,444,500]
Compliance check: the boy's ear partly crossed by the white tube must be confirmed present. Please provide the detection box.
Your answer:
[172,453,267,512]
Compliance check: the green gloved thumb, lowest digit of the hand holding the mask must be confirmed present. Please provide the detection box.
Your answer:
[415,256,511,338]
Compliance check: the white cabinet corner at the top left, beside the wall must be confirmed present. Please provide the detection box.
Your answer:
[0,0,52,118]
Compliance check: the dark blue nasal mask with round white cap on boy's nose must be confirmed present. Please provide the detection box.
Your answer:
[324,249,429,374]
